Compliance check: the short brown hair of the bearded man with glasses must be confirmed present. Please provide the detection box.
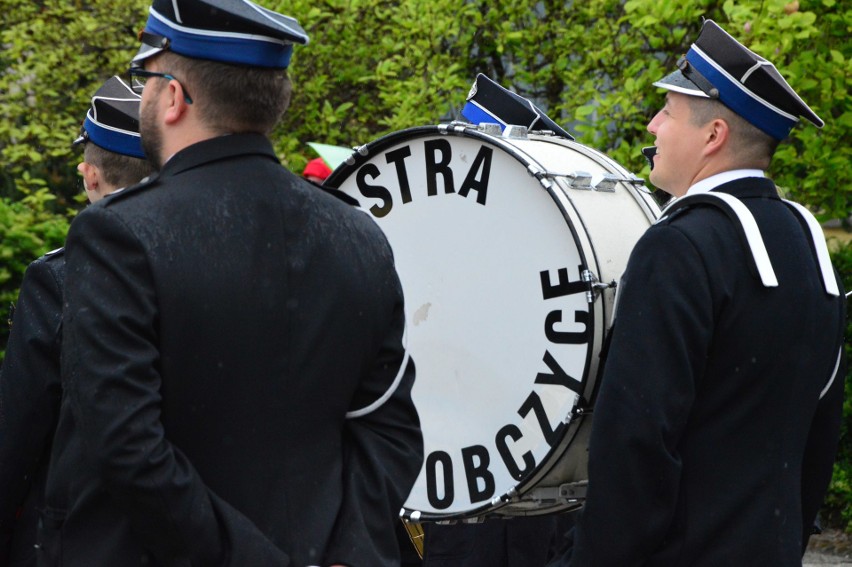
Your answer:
[157,51,292,135]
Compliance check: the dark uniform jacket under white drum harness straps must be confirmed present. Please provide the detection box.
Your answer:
[571,178,845,567]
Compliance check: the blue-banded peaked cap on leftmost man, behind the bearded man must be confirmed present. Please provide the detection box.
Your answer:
[74,77,145,159]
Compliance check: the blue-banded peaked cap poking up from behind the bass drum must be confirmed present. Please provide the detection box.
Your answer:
[461,73,574,140]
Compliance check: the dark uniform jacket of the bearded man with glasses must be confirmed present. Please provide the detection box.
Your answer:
[39,134,422,567]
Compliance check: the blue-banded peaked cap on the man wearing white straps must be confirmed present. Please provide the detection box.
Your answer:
[654,20,825,140]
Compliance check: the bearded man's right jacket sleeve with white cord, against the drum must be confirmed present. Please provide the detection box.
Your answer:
[325,264,423,567]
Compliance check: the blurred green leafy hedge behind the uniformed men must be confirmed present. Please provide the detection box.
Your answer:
[0,0,852,526]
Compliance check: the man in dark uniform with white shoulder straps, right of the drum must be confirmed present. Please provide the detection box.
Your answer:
[562,17,846,567]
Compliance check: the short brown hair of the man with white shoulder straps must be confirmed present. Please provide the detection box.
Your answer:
[688,96,779,169]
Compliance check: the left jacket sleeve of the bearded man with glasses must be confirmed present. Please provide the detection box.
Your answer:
[62,206,289,565]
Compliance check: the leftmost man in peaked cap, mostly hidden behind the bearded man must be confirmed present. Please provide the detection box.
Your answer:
[0,77,153,566]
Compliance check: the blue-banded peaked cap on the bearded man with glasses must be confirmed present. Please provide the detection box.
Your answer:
[132,0,308,69]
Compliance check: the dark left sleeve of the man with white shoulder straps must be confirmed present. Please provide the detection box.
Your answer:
[571,226,713,567]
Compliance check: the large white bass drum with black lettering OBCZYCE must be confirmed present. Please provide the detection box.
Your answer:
[325,123,659,522]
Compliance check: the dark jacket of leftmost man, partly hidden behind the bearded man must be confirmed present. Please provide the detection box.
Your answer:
[0,249,65,566]
